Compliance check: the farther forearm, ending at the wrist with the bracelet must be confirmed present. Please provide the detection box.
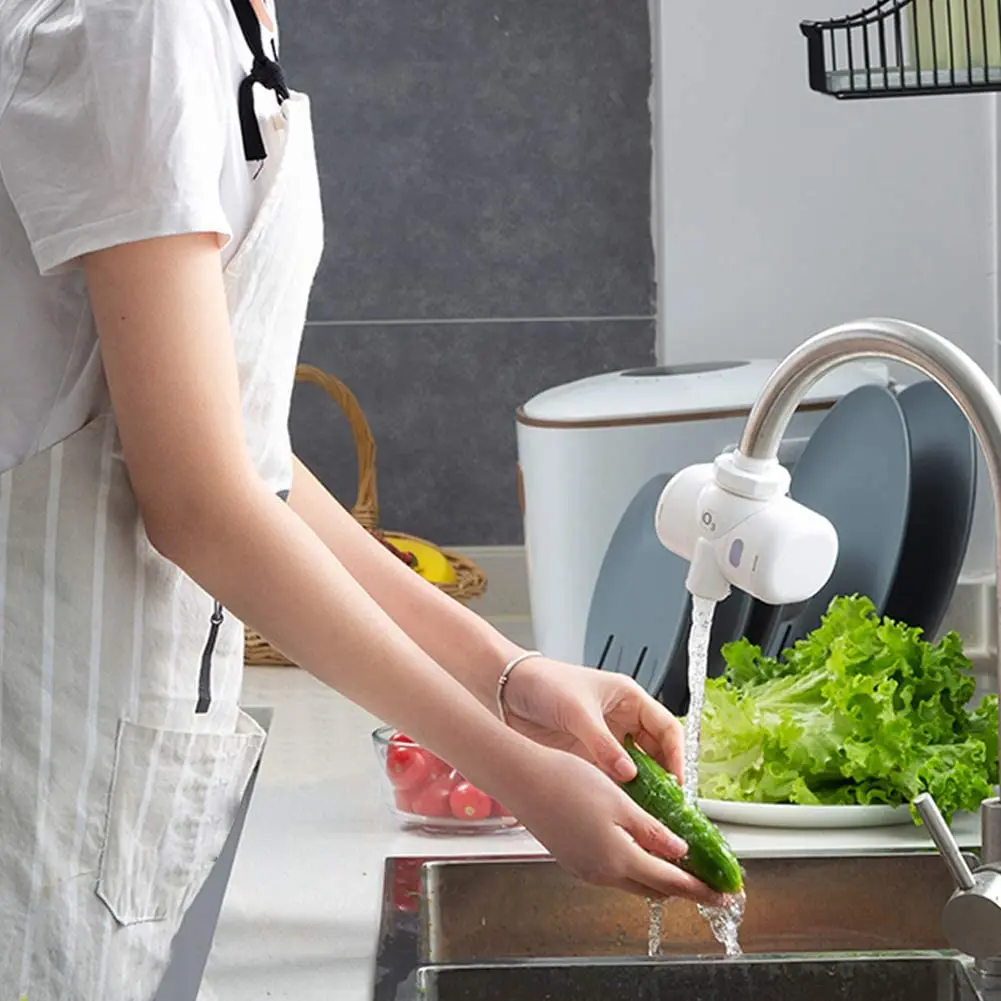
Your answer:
[288,459,521,711]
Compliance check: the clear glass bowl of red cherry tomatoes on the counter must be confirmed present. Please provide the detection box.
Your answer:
[372,727,522,835]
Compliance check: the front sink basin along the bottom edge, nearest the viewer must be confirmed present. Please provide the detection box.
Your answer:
[419,957,977,1001]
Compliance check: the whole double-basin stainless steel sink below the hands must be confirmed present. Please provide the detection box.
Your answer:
[373,852,976,1001]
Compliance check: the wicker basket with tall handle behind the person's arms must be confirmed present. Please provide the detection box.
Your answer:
[245,365,486,667]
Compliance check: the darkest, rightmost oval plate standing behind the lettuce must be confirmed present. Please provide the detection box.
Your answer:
[885,380,977,638]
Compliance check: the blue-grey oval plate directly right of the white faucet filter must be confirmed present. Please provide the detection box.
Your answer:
[747,385,911,657]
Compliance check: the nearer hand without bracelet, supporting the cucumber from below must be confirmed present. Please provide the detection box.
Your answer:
[503,747,723,907]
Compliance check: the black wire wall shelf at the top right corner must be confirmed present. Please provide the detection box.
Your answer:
[800,0,1001,100]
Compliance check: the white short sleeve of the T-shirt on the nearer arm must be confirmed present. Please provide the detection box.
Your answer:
[0,0,237,274]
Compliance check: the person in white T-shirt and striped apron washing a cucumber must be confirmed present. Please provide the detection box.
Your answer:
[0,0,714,1001]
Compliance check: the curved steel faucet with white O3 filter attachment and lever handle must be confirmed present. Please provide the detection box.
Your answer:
[657,319,1001,968]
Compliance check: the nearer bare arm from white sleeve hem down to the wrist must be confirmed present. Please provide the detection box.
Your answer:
[85,235,518,771]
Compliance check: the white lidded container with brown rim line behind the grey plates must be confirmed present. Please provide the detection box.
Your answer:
[517,360,889,663]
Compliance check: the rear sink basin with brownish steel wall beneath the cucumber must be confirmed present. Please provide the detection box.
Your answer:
[419,854,953,964]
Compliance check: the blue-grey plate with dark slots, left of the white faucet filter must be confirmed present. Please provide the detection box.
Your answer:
[585,473,751,714]
